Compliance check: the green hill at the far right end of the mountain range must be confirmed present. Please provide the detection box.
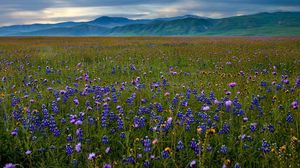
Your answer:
[205,12,300,35]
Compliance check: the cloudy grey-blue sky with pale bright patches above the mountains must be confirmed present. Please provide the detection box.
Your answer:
[0,0,300,26]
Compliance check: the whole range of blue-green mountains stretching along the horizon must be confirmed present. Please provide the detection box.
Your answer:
[0,12,300,36]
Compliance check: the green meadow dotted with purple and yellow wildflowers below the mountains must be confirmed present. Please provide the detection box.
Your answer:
[0,37,300,168]
